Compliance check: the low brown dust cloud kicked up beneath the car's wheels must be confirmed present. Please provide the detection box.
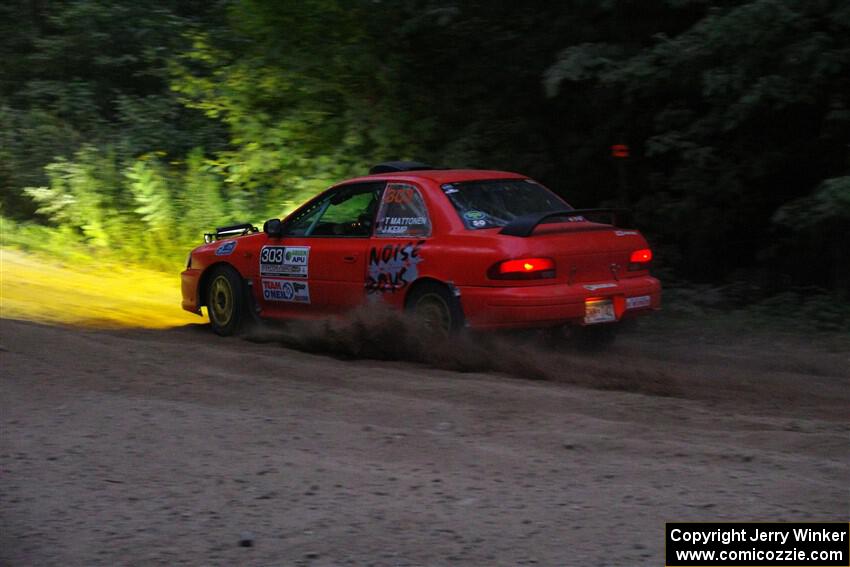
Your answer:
[240,305,679,396]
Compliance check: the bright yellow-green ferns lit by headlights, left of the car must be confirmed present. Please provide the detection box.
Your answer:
[17,147,229,269]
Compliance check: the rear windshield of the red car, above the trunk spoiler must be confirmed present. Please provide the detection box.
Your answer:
[442,179,572,230]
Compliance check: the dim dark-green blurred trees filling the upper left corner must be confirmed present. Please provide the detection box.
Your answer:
[0,0,226,219]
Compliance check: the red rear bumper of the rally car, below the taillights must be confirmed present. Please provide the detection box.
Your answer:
[459,276,661,329]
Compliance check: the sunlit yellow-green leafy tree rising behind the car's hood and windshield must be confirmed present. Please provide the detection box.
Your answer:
[172,1,396,209]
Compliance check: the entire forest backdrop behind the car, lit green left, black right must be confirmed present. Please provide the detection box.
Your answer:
[0,0,850,297]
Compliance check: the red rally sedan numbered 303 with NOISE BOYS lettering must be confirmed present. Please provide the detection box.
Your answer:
[181,162,661,342]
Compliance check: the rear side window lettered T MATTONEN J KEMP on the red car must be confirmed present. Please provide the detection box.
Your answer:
[375,183,431,237]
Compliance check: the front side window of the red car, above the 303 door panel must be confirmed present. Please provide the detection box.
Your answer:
[284,183,383,237]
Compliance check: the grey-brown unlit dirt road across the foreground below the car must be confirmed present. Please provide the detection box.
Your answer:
[0,320,850,565]
